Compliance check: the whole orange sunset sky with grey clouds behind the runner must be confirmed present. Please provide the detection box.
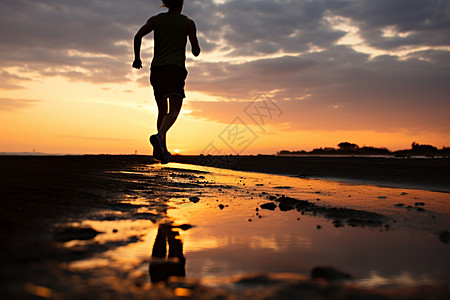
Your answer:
[0,0,450,154]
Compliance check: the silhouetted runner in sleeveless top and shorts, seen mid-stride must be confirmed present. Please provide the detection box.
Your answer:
[133,0,200,164]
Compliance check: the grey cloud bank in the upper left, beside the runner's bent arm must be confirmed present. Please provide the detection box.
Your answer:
[0,0,158,83]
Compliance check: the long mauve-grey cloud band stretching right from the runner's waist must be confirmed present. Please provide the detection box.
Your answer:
[188,46,450,98]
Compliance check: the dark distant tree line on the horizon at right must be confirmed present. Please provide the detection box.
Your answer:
[277,142,450,157]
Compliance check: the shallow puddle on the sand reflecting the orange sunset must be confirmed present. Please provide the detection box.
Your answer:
[60,163,450,287]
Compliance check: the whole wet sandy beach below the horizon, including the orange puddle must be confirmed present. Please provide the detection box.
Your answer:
[0,155,450,299]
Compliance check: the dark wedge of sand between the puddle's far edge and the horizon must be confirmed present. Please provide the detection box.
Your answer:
[172,155,450,193]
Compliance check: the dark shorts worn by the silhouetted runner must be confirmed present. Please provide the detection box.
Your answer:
[150,65,187,100]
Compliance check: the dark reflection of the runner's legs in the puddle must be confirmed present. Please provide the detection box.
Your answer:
[149,224,186,282]
